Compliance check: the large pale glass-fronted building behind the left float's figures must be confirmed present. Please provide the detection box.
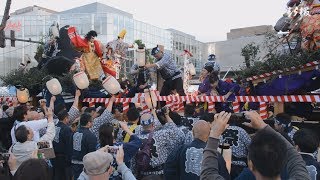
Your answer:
[0,3,173,75]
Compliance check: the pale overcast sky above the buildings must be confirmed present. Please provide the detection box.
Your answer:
[0,0,287,42]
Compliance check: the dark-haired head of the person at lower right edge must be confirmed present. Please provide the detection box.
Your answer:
[293,129,319,153]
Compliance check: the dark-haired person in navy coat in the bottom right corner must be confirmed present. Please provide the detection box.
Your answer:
[293,129,320,180]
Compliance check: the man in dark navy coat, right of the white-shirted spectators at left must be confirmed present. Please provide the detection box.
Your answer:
[52,110,73,180]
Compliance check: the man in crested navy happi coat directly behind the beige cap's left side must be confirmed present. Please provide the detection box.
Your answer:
[71,113,98,179]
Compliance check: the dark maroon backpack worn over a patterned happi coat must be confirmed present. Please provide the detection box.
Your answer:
[136,132,153,171]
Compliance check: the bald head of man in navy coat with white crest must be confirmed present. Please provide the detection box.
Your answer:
[192,120,211,142]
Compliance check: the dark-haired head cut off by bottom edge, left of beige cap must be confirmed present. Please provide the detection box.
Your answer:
[13,159,52,180]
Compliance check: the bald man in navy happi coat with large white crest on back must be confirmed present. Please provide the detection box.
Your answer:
[164,120,230,180]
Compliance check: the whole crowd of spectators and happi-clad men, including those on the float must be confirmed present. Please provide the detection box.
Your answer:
[0,47,320,180]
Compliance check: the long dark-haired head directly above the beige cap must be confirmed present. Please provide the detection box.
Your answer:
[99,123,113,147]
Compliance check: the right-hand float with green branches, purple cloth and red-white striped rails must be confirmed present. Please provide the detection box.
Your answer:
[238,0,320,126]
